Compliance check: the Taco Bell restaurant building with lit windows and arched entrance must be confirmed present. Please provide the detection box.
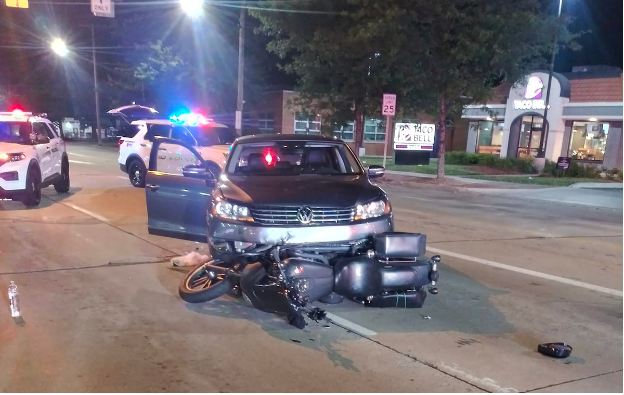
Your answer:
[462,66,622,169]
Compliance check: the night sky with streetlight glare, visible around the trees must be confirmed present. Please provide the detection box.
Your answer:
[0,0,624,116]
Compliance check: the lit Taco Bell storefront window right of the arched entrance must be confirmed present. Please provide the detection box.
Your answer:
[568,122,609,161]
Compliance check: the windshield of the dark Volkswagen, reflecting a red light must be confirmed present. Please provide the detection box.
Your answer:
[227,141,362,176]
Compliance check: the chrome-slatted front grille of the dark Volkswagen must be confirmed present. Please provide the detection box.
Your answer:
[251,206,355,225]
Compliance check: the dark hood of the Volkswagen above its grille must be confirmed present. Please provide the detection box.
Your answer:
[219,175,384,208]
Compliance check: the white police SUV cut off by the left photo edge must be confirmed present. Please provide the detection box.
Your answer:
[0,110,69,206]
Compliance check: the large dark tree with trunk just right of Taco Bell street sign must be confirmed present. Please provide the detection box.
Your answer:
[351,0,576,178]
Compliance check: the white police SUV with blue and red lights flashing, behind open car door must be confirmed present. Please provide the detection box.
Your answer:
[118,114,236,188]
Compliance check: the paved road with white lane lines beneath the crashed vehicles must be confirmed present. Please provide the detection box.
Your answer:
[0,144,623,392]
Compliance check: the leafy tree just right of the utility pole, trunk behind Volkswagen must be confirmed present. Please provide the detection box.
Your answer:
[250,0,408,152]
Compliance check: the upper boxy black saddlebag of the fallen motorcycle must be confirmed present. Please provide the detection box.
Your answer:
[374,232,427,260]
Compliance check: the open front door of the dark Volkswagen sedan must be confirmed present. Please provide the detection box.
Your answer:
[145,137,218,242]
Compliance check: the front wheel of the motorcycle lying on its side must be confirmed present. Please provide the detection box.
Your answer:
[178,261,234,303]
